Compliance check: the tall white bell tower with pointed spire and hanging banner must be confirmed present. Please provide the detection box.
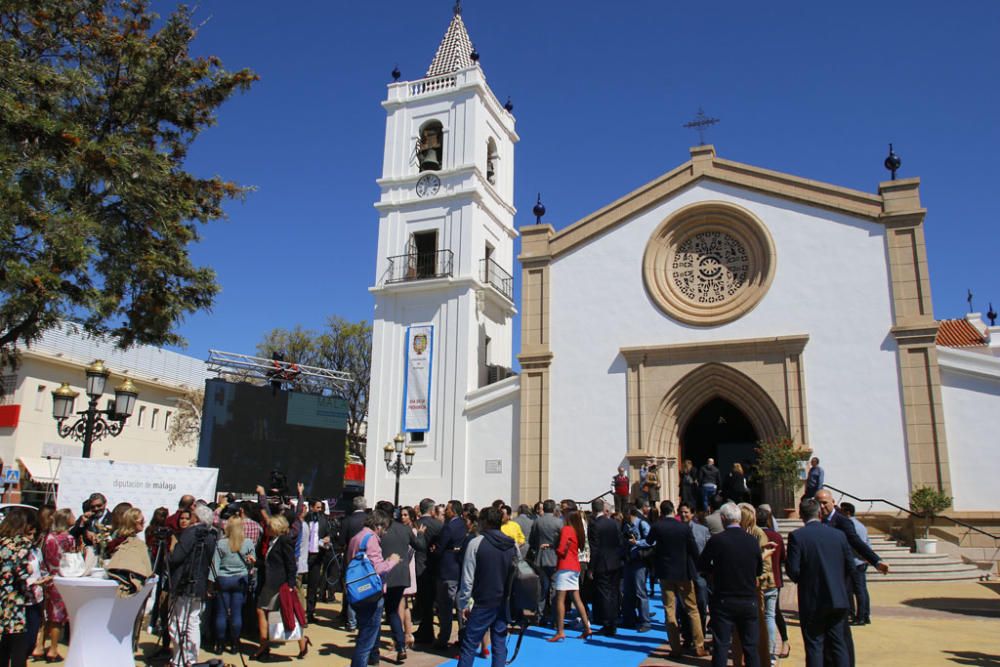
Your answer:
[365,3,518,502]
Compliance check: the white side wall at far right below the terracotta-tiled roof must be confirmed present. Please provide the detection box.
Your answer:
[941,364,1000,512]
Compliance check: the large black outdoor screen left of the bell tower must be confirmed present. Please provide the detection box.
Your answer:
[198,380,347,498]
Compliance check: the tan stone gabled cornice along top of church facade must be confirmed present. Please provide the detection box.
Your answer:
[549,146,919,256]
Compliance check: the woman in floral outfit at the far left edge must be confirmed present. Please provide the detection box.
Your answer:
[0,507,38,667]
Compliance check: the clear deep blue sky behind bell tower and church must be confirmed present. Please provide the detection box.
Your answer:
[166,0,1000,357]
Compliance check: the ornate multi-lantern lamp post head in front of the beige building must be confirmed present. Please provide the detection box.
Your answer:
[52,359,139,459]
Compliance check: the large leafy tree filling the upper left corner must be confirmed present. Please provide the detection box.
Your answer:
[0,0,257,368]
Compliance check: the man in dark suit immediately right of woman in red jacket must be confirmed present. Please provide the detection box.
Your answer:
[587,500,624,637]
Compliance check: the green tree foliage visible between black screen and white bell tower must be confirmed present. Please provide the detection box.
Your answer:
[257,316,372,459]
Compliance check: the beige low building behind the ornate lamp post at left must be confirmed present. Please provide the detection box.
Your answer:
[0,324,209,502]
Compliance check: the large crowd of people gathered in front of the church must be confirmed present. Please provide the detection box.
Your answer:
[0,461,888,667]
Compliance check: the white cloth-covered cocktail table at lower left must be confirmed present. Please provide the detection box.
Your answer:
[54,576,156,667]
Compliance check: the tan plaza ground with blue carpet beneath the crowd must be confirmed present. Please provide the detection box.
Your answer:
[92,582,1000,667]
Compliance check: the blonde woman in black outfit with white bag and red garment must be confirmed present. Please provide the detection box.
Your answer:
[250,514,310,660]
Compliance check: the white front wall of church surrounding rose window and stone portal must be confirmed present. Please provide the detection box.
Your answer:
[550,182,908,502]
